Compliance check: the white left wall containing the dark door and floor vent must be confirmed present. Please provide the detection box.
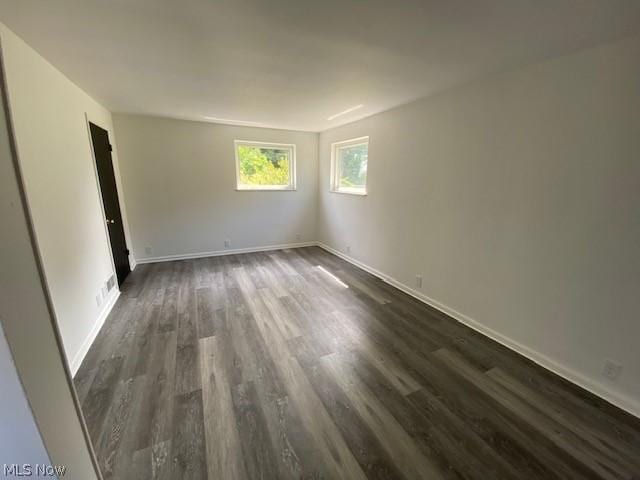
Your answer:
[0,24,132,369]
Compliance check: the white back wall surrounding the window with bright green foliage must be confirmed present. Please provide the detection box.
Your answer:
[114,114,318,261]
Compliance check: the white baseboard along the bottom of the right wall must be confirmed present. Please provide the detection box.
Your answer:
[316,242,640,418]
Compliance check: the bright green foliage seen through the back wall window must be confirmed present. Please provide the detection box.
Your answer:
[238,145,290,186]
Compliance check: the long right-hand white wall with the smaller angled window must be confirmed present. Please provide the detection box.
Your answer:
[318,37,640,415]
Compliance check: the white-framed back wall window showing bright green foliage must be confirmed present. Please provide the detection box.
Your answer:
[234,140,296,190]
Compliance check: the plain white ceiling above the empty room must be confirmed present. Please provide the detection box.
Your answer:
[0,0,640,131]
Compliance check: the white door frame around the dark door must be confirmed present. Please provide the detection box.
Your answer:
[84,112,136,284]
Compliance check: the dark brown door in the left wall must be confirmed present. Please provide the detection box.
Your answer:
[89,123,131,285]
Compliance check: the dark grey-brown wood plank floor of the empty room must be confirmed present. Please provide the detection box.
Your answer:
[75,248,640,480]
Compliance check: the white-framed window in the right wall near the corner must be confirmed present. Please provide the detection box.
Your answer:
[331,137,369,195]
